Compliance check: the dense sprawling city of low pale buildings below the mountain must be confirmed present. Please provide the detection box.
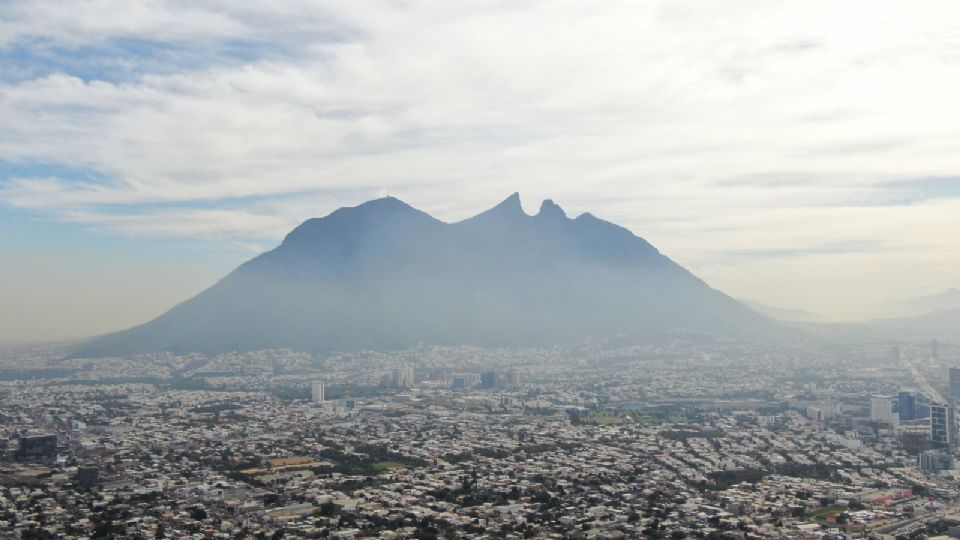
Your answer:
[0,341,960,538]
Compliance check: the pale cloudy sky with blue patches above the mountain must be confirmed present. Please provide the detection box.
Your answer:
[0,0,960,341]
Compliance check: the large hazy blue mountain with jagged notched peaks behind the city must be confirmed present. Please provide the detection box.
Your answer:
[74,194,776,357]
